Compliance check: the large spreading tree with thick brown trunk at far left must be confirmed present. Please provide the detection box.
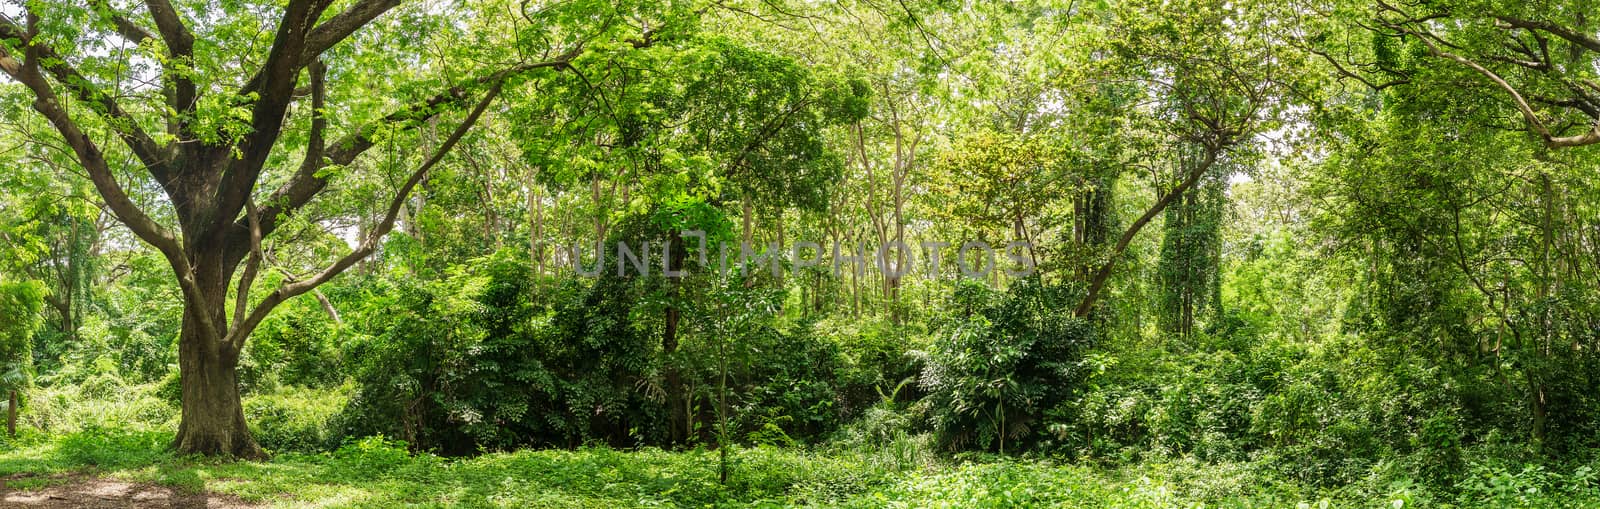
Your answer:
[0,0,659,458]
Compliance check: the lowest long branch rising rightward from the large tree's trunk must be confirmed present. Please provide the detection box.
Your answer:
[224,82,501,352]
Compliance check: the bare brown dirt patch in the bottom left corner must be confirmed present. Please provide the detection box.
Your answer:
[0,477,259,509]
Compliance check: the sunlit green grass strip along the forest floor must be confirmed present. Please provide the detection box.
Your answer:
[0,429,1600,509]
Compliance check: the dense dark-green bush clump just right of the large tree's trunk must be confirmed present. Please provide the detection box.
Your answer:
[338,250,662,455]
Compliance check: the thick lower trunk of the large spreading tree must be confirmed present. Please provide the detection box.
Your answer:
[173,312,266,459]
